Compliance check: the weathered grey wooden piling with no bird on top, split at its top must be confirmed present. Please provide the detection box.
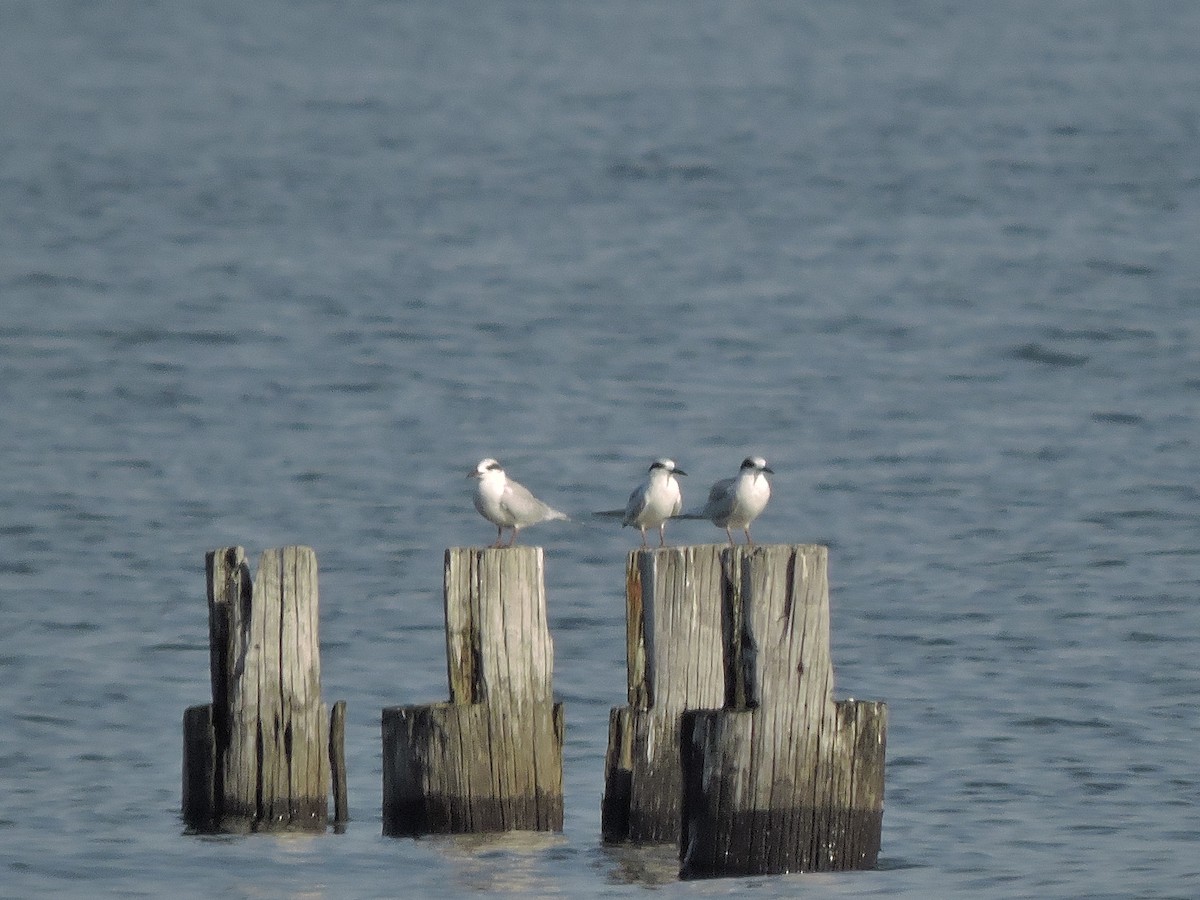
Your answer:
[182,547,347,832]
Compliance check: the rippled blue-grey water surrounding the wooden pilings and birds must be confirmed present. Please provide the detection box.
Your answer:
[0,0,1200,898]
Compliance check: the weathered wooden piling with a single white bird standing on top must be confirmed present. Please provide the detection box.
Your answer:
[383,547,564,835]
